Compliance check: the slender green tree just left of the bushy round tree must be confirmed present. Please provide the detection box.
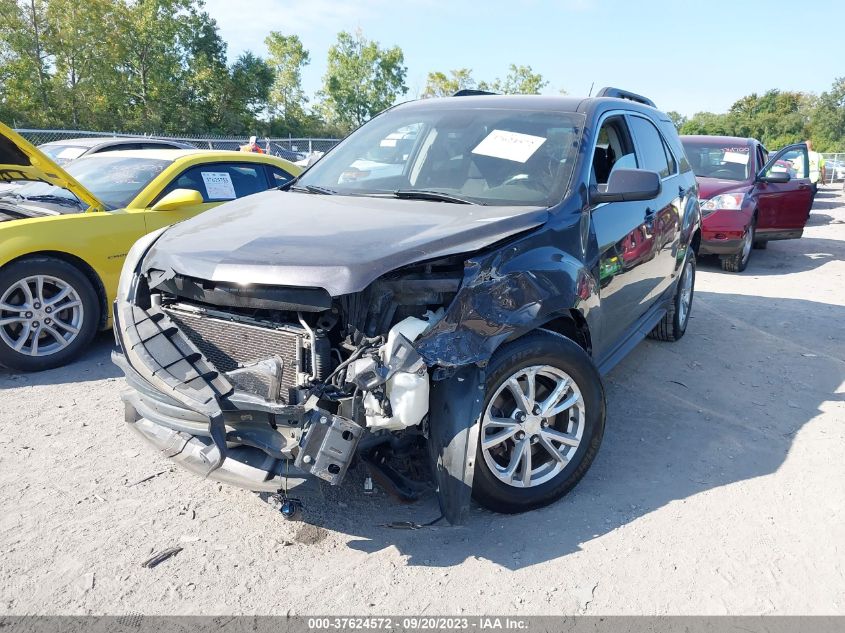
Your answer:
[264,31,311,124]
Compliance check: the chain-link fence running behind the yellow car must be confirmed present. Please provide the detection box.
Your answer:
[15,128,339,161]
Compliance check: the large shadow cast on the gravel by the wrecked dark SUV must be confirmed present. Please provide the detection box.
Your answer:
[286,292,845,569]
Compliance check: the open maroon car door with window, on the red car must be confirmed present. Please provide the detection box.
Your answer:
[755,143,813,241]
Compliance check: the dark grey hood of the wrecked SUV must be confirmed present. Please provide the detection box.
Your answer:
[143,190,548,296]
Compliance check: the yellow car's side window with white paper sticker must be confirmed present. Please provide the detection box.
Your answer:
[158,163,269,202]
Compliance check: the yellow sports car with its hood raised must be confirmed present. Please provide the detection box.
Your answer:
[0,123,301,371]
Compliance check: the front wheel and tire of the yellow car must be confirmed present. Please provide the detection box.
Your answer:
[0,257,100,371]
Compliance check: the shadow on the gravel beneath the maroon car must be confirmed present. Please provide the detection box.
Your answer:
[698,233,845,276]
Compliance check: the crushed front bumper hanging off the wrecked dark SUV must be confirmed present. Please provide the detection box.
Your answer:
[112,302,322,491]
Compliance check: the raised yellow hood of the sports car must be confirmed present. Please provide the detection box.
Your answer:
[0,118,105,210]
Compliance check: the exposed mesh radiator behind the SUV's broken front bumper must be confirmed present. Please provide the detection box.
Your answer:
[165,306,306,403]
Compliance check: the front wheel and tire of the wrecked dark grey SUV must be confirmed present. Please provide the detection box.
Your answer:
[472,330,605,514]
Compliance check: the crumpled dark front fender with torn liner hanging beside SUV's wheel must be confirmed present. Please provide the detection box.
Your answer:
[415,220,598,524]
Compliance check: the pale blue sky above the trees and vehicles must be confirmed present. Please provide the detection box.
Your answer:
[206,0,845,115]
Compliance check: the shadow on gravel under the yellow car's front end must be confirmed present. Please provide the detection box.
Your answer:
[0,330,123,391]
